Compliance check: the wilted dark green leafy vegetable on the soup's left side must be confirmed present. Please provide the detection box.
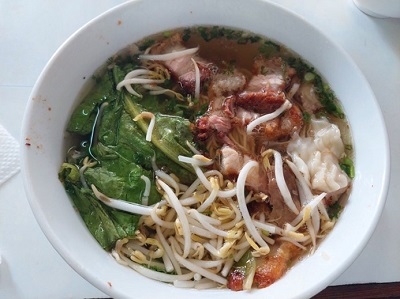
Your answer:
[59,60,194,250]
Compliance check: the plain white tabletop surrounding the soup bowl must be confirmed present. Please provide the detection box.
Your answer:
[0,0,400,299]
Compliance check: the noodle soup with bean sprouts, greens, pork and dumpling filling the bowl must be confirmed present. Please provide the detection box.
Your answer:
[59,26,354,291]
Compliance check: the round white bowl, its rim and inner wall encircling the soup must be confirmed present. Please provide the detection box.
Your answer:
[22,0,389,299]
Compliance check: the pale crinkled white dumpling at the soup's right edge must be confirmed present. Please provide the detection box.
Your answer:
[288,118,349,193]
